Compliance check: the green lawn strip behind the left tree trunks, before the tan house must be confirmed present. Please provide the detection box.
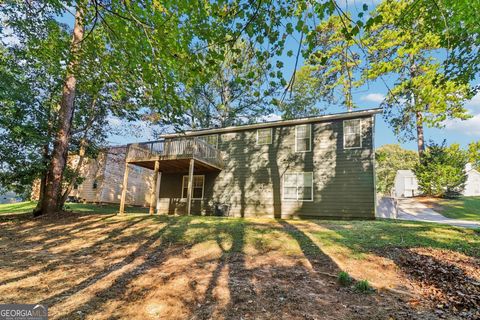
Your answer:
[0,201,148,215]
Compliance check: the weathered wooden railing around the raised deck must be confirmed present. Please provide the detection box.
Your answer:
[127,138,223,168]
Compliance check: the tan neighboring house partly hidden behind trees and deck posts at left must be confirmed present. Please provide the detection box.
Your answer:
[32,146,153,206]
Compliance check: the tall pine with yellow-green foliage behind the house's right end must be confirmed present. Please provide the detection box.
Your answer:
[363,0,472,156]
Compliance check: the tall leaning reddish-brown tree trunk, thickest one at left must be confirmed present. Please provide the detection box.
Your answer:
[37,3,84,215]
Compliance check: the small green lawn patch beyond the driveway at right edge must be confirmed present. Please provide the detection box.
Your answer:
[436,197,480,221]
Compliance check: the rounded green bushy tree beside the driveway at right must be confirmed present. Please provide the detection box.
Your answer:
[414,142,468,198]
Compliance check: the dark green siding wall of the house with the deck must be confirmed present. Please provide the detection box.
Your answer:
[158,116,375,219]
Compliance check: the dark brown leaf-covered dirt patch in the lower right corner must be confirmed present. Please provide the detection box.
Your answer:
[388,248,480,319]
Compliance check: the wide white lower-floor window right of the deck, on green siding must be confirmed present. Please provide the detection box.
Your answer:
[283,172,313,201]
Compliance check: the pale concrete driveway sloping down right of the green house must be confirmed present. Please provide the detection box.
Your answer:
[397,198,480,228]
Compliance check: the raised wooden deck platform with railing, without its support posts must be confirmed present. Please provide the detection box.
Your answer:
[126,138,224,173]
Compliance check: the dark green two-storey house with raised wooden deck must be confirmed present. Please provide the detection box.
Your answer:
[120,109,381,219]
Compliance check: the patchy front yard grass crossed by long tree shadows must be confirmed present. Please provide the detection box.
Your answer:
[0,211,480,319]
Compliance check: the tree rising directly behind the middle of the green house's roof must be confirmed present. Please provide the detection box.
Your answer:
[169,39,279,128]
